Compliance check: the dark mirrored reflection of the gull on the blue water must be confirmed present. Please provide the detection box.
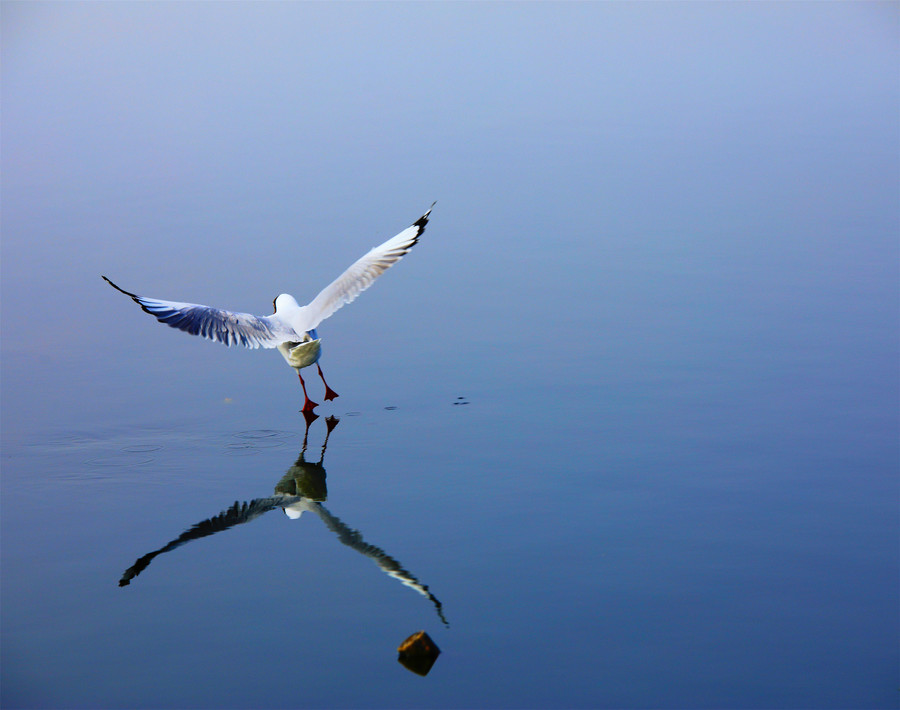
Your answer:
[119,412,449,626]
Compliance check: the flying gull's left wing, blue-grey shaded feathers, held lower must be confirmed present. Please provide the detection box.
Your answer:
[103,276,301,348]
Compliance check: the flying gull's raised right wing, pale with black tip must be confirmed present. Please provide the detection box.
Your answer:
[295,204,434,331]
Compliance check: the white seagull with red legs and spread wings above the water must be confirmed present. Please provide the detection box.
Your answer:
[102,204,434,413]
